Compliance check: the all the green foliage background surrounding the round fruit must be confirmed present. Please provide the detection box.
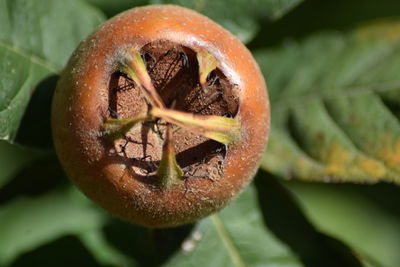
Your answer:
[0,0,400,267]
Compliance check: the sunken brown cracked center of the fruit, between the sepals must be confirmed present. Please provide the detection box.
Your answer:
[107,40,239,182]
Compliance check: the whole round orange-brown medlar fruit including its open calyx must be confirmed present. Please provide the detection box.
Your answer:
[52,5,270,227]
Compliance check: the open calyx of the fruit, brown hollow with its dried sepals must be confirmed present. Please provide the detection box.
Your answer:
[103,41,240,189]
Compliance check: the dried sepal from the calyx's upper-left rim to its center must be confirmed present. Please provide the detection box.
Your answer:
[118,48,164,108]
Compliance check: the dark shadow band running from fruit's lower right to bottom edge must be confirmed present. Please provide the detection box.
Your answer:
[255,171,362,267]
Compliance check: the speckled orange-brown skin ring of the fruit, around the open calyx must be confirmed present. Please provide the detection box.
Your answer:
[52,5,270,227]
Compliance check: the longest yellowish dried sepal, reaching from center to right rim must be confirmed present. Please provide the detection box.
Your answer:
[150,107,240,145]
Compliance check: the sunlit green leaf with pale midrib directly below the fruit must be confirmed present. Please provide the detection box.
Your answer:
[162,186,302,266]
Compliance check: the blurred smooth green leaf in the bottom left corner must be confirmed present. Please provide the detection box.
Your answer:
[0,189,104,266]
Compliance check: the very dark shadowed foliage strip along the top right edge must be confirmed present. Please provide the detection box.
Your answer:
[249,0,400,50]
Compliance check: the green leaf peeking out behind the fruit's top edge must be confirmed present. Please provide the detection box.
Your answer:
[150,0,302,43]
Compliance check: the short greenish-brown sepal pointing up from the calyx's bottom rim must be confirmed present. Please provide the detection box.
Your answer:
[156,124,184,189]
